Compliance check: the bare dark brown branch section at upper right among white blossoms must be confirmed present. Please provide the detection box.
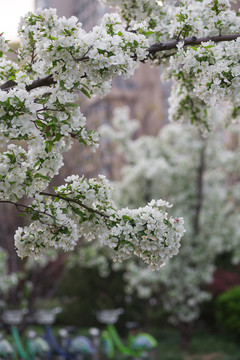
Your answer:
[148,34,240,54]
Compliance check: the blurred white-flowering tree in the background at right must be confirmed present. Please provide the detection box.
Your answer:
[100,107,240,323]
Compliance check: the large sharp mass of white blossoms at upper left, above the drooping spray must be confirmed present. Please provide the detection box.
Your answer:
[0,9,148,199]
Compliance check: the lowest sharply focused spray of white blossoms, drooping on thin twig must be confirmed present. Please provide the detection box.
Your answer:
[15,175,185,269]
